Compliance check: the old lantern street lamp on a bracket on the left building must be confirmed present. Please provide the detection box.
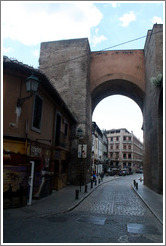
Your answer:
[17,75,39,107]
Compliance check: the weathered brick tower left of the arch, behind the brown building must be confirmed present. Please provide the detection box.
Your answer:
[39,38,91,182]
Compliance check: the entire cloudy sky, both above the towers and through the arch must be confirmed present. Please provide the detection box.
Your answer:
[1,1,165,141]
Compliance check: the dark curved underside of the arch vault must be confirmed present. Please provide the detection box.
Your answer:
[91,79,144,114]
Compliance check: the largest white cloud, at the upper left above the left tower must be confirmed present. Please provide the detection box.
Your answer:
[1,1,102,45]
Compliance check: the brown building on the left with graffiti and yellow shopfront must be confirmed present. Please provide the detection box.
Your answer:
[3,57,76,208]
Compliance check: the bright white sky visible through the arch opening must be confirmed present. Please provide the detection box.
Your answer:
[92,95,143,142]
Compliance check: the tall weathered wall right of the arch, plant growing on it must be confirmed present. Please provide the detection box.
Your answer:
[143,24,163,192]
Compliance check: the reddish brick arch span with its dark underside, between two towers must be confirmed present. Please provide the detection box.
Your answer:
[90,50,145,112]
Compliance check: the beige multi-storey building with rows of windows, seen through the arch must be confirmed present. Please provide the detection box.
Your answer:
[106,128,143,172]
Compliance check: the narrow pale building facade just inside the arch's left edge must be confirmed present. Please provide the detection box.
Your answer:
[92,122,108,174]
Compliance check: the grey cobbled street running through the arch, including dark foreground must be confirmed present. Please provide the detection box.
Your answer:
[4,175,162,244]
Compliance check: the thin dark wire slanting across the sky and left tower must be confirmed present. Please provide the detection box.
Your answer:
[40,31,162,69]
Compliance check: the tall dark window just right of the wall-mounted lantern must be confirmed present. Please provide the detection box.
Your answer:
[32,95,43,132]
